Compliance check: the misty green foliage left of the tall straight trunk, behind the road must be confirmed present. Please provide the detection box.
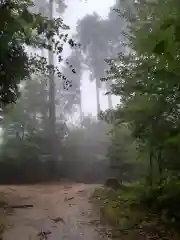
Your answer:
[0,76,68,183]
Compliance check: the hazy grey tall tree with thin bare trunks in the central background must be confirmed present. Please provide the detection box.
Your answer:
[77,1,127,114]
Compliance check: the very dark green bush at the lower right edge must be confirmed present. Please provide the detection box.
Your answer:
[139,178,180,229]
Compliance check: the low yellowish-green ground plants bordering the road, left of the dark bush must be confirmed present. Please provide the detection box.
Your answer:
[92,185,179,240]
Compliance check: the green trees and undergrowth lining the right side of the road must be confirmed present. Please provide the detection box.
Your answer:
[96,0,180,239]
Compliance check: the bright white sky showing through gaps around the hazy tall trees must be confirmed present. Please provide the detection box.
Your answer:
[64,0,121,116]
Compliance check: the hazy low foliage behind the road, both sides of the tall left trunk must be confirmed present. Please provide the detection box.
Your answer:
[0,100,109,183]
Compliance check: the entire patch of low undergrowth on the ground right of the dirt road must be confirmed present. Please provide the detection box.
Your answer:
[92,183,180,240]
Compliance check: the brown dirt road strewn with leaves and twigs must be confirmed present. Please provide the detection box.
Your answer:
[0,184,109,240]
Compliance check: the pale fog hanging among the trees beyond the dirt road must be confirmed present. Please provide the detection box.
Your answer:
[0,0,126,183]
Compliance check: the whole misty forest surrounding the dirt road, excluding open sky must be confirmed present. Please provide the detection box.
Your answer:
[0,0,180,239]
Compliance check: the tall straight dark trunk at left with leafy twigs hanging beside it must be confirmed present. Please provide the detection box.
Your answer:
[32,0,75,171]
